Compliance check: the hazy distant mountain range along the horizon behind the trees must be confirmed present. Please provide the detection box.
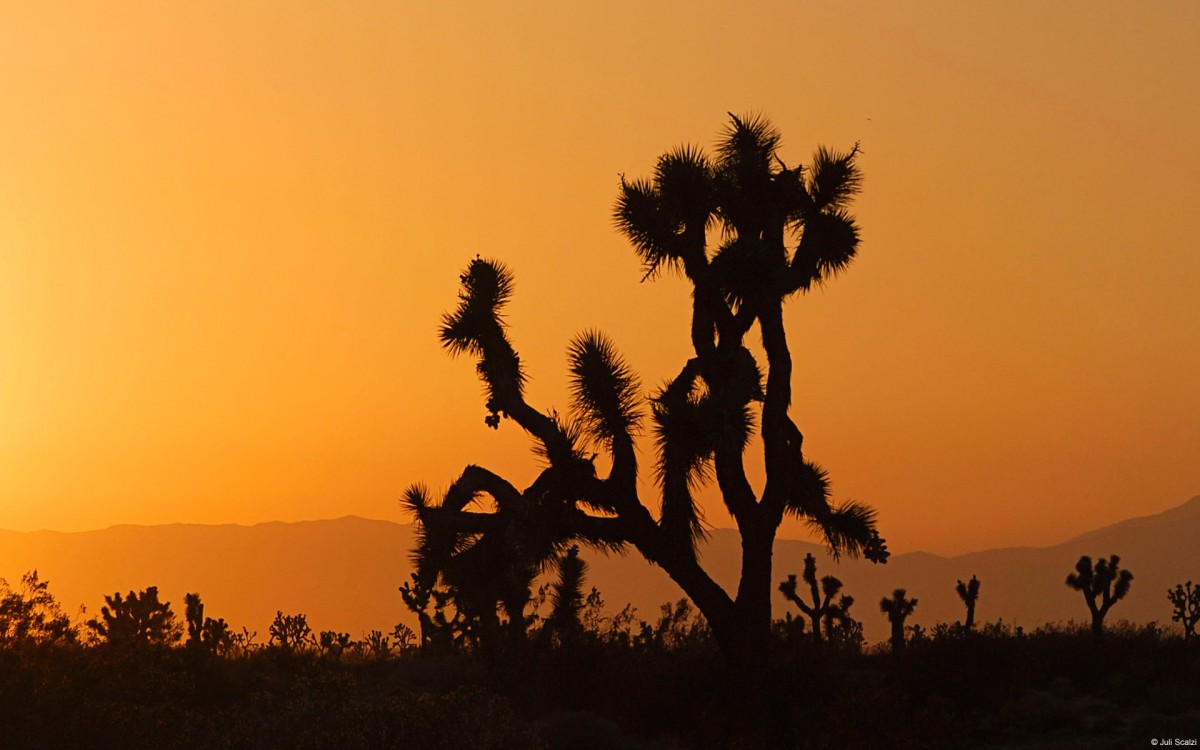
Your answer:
[0,497,1200,642]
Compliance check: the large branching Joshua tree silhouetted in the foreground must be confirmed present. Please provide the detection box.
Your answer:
[404,115,887,660]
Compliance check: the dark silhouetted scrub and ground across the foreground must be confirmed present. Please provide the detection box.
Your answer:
[0,571,1200,750]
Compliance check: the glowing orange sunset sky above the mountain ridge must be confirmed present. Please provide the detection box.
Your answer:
[0,0,1200,552]
